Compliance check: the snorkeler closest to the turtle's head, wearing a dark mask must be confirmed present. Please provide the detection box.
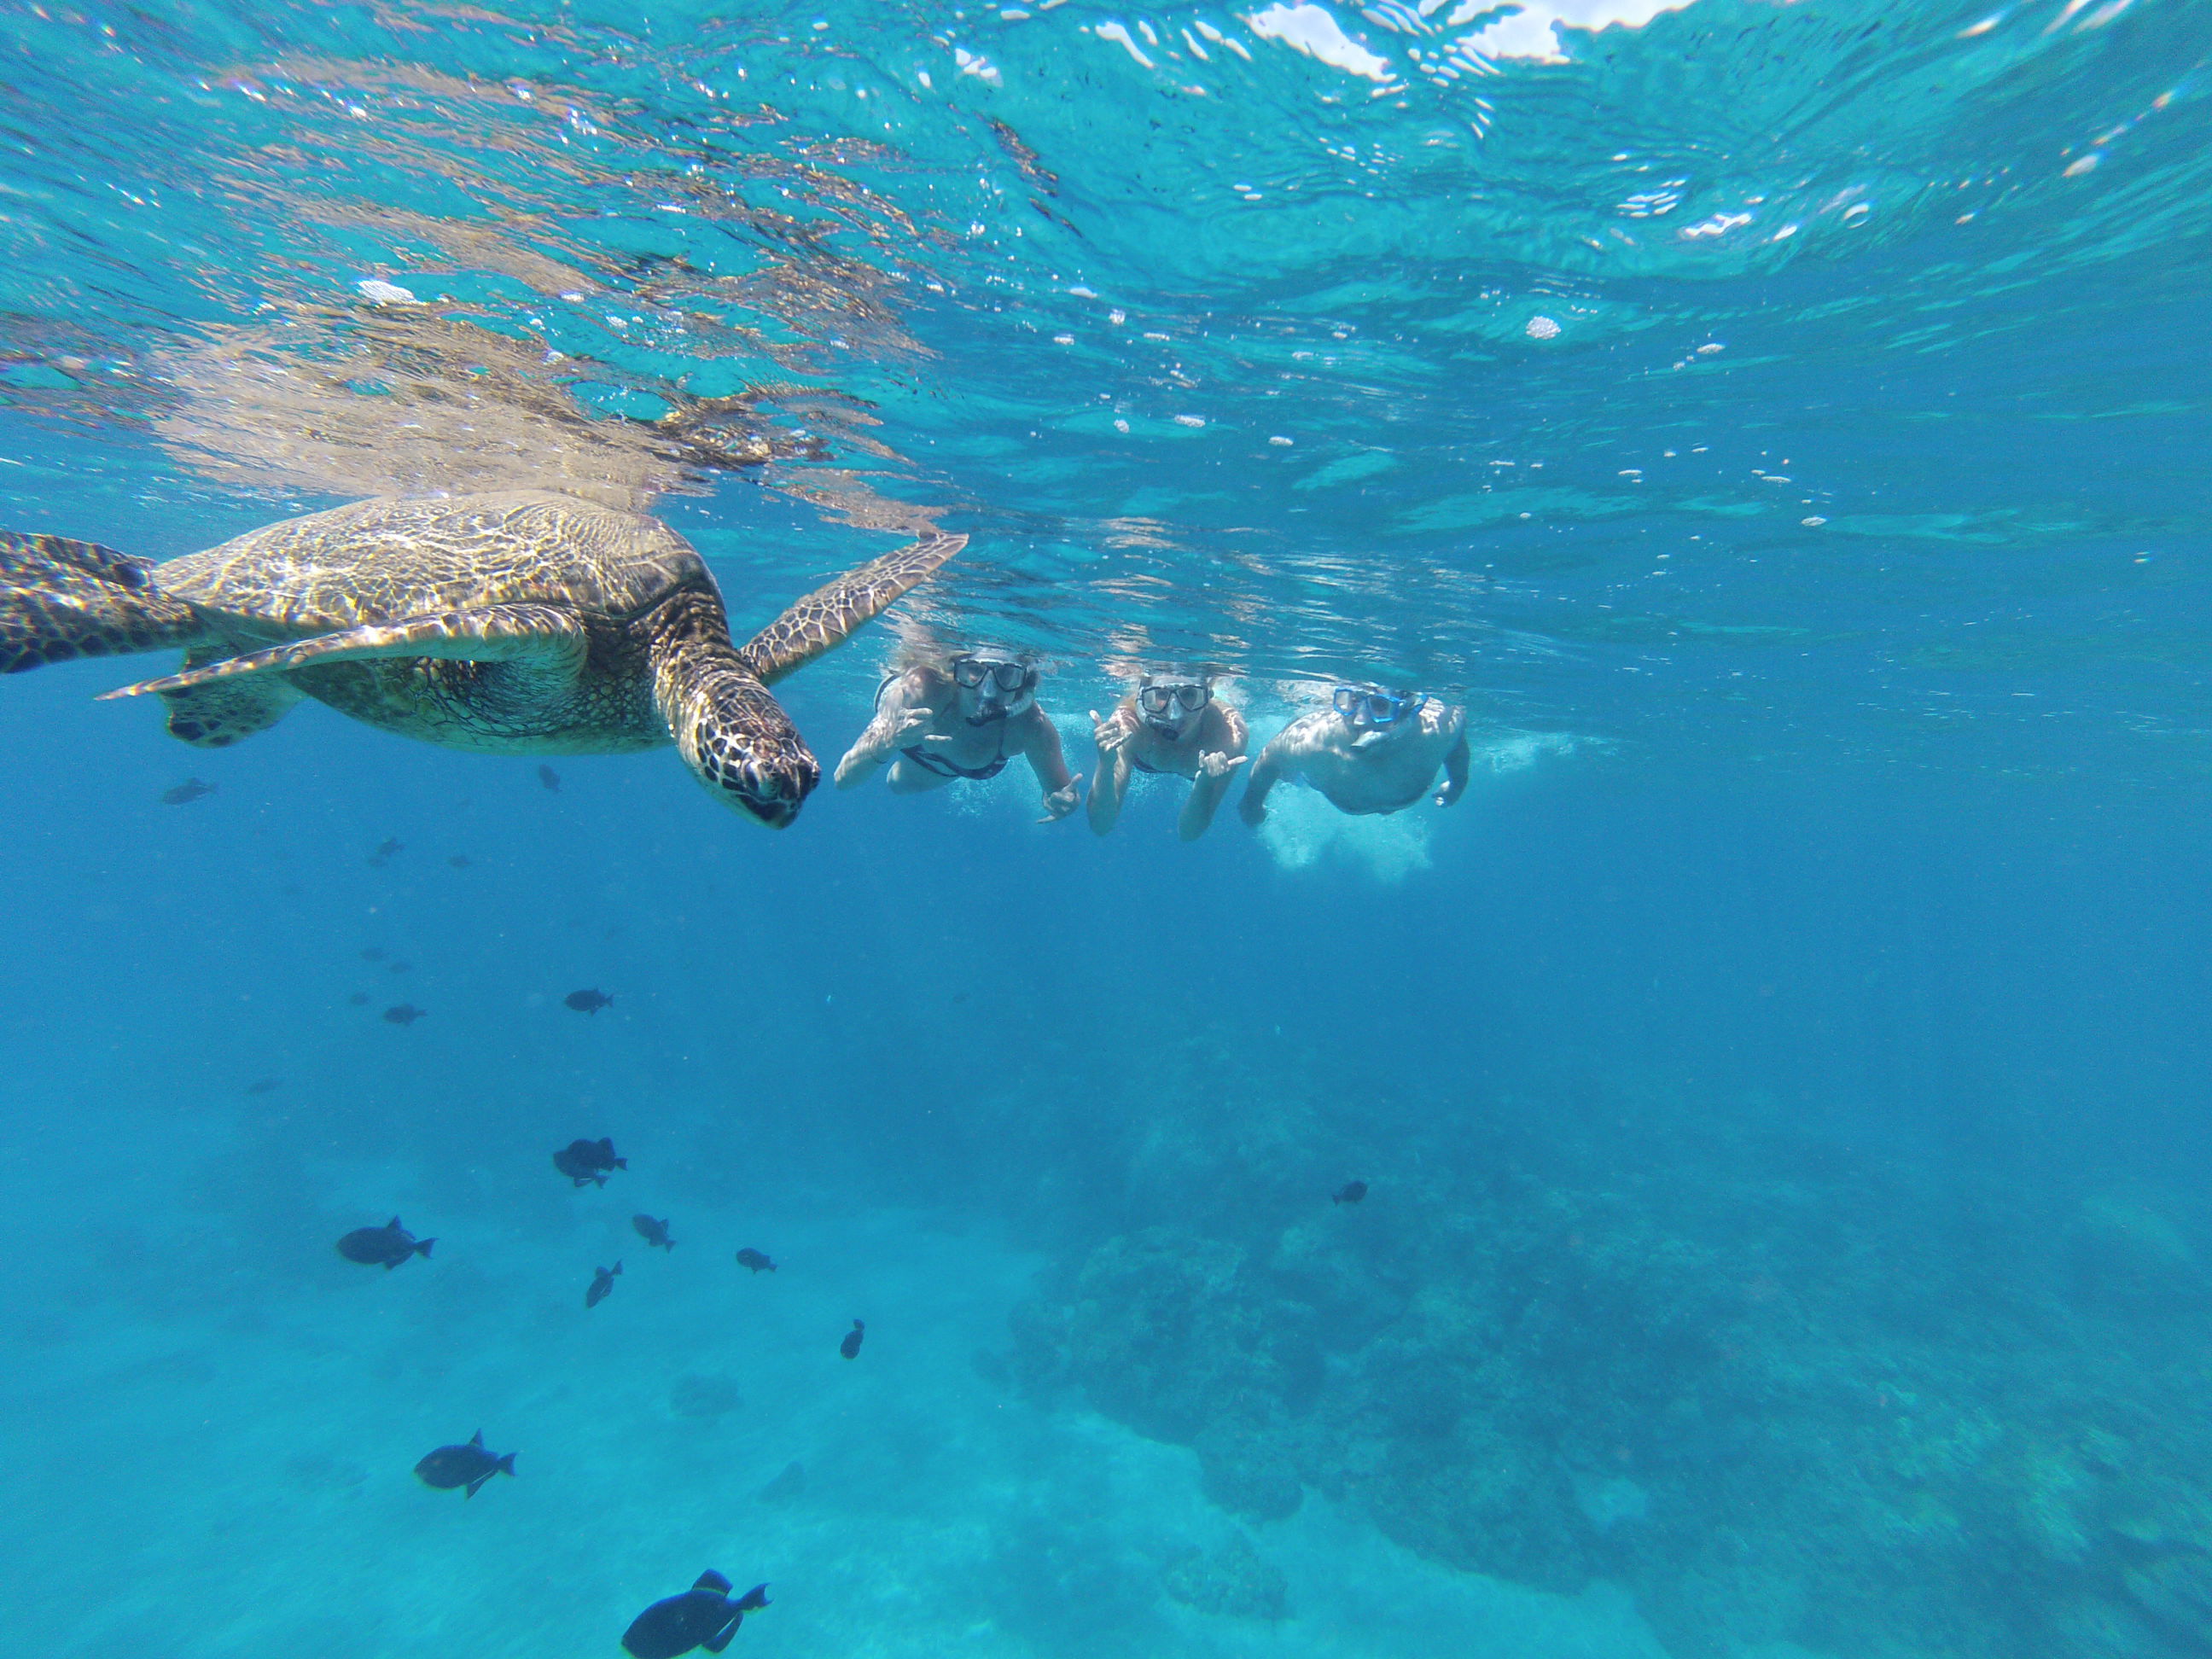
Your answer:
[836,646,1081,823]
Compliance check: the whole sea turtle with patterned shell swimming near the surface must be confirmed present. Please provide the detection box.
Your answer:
[0,491,967,830]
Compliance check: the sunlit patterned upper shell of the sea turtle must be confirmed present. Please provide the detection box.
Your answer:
[153,491,713,635]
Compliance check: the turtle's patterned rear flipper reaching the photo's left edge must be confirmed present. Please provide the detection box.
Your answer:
[0,531,203,675]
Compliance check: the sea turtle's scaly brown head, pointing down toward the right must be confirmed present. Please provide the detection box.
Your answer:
[653,643,823,830]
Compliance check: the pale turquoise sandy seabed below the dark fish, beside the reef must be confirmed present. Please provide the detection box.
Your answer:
[0,1120,1662,1659]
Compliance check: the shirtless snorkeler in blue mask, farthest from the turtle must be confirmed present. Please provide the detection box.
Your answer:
[1237,686,1466,823]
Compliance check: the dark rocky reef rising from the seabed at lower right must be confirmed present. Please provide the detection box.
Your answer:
[1006,1066,2212,1659]
